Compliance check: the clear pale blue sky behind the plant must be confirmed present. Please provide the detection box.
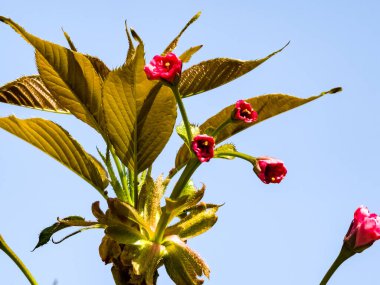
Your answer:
[0,0,380,285]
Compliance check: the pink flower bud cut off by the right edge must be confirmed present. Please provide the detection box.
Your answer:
[344,206,380,252]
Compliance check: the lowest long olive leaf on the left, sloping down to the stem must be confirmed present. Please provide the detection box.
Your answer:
[0,116,108,192]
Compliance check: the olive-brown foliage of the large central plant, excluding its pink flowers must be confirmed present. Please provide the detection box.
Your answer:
[0,13,341,284]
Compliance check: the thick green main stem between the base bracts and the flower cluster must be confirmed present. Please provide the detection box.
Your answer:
[155,159,201,243]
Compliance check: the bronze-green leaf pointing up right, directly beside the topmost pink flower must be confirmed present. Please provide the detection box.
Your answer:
[179,44,288,98]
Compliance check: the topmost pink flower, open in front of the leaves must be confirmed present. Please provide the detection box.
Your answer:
[144,52,182,84]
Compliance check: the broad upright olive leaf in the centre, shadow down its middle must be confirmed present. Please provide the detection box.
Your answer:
[103,41,176,173]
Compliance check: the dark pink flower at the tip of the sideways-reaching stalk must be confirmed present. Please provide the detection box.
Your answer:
[253,157,288,184]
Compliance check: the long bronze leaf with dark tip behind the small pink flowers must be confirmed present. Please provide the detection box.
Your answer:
[175,87,342,169]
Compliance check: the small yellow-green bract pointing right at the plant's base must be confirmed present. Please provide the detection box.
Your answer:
[165,206,219,240]
